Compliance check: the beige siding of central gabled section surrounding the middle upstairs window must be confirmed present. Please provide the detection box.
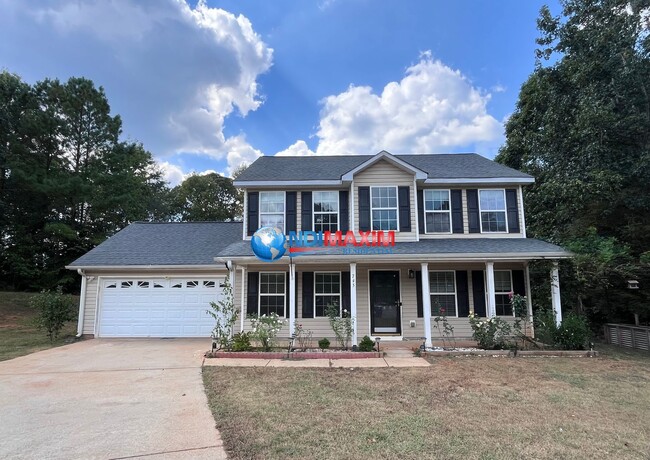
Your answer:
[352,160,418,241]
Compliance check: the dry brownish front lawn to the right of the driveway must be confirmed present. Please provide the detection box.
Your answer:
[204,346,650,459]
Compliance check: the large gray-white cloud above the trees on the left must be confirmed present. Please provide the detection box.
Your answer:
[0,0,273,177]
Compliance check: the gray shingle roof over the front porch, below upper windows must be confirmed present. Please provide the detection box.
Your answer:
[219,238,571,260]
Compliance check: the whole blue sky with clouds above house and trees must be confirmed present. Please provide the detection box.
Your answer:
[0,0,560,184]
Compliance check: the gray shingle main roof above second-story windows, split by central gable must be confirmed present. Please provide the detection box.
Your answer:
[237,153,531,182]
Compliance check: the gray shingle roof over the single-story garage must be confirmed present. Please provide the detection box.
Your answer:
[69,222,242,268]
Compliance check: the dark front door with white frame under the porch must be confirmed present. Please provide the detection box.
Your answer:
[370,271,402,335]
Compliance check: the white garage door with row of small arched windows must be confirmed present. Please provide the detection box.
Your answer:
[98,277,224,337]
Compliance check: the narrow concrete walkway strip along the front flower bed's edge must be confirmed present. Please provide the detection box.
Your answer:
[204,357,430,368]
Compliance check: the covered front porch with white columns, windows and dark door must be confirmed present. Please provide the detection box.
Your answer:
[225,257,562,346]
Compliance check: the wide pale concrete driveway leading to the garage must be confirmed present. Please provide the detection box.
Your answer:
[0,339,226,459]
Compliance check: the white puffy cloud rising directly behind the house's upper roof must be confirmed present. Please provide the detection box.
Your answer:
[280,52,503,156]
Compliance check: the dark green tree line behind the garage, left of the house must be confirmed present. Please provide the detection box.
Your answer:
[0,71,241,290]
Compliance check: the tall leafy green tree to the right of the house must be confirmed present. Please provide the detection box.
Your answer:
[497,0,650,320]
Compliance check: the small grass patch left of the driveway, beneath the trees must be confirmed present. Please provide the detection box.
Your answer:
[0,292,77,361]
